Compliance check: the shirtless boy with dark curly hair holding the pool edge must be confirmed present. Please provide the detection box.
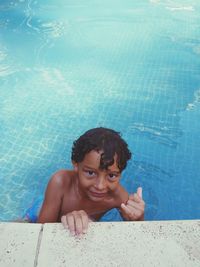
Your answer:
[37,127,145,235]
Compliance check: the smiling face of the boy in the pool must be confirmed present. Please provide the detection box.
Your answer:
[74,150,121,201]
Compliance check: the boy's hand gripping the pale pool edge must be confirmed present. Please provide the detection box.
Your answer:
[61,210,92,235]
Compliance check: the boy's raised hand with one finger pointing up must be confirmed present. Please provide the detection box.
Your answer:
[121,187,145,221]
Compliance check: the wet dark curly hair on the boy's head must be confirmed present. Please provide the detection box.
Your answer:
[71,127,131,172]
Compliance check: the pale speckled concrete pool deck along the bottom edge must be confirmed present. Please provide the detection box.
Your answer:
[0,220,200,267]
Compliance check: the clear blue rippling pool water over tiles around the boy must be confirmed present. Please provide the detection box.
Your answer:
[0,0,200,221]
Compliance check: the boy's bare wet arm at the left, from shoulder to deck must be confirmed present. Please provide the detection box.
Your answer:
[37,173,63,223]
